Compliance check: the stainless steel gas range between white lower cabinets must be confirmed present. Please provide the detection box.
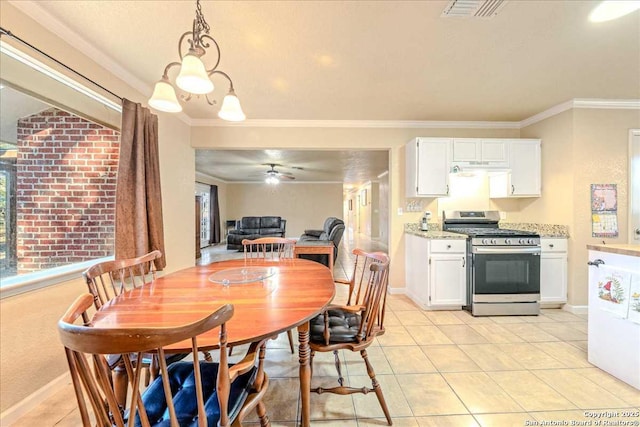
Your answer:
[442,211,540,316]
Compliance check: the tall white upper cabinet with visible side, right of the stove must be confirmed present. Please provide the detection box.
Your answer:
[489,139,542,198]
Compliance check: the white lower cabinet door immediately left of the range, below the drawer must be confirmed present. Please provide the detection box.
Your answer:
[429,254,467,306]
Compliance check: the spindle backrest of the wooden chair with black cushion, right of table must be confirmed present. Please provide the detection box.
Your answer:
[356,252,389,341]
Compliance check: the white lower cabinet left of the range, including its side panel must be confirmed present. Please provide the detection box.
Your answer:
[405,234,467,310]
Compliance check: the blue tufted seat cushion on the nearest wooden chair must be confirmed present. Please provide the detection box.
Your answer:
[132,362,257,427]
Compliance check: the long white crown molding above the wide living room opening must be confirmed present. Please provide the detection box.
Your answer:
[191,119,520,129]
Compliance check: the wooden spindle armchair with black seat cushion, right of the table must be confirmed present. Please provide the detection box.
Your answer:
[309,249,392,425]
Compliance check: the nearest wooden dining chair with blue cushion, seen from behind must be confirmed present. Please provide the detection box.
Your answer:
[58,294,270,427]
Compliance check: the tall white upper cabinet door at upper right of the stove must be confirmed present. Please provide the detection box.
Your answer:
[507,140,541,197]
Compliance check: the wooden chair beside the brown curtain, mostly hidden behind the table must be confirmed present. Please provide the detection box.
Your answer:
[82,250,211,404]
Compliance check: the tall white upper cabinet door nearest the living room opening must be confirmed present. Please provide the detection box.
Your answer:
[416,138,451,197]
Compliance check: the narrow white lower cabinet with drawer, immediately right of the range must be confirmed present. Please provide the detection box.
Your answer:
[540,238,568,304]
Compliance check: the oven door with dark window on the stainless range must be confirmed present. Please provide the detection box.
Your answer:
[471,246,540,302]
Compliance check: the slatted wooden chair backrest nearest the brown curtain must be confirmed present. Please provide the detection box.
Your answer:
[82,251,162,308]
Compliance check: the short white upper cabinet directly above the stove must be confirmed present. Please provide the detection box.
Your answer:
[451,138,509,167]
